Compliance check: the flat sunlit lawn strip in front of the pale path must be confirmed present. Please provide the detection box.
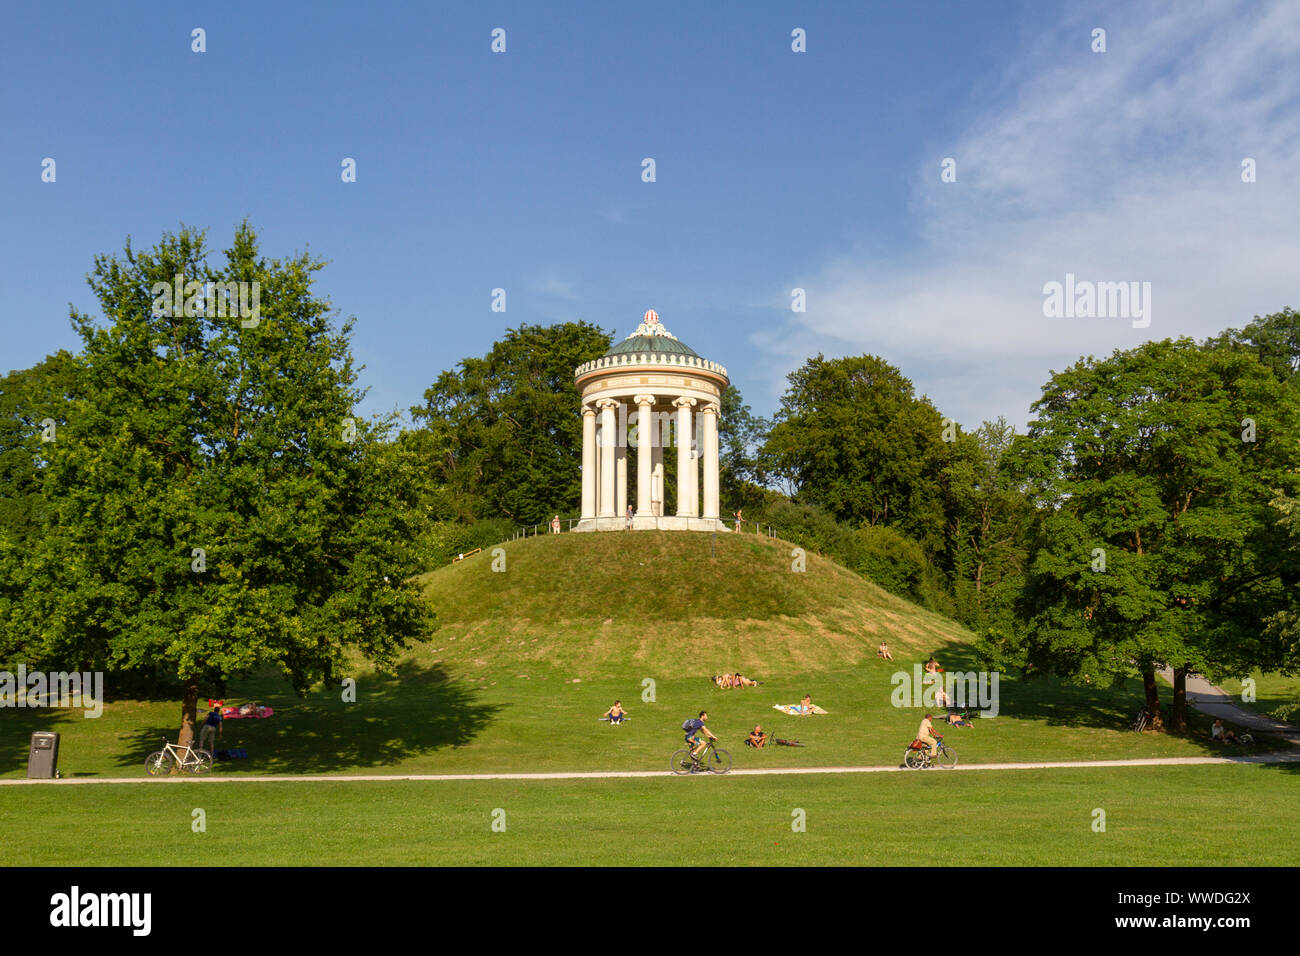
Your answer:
[0,765,1300,868]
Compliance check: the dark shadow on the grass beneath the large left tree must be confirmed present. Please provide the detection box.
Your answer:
[116,663,501,774]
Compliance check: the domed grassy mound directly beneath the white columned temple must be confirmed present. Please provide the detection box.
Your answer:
[410,532,971,678]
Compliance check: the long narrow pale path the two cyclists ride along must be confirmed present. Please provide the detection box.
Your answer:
[0,750,1300,787]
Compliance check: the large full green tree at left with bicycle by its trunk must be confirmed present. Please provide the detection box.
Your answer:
[0,225,430,743]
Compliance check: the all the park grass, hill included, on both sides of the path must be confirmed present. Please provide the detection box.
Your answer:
[0,535,1300,866]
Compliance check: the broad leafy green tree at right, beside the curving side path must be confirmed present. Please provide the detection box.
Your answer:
[988,338,1300,728]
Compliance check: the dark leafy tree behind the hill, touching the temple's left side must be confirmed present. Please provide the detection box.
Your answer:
[411,321,611,523]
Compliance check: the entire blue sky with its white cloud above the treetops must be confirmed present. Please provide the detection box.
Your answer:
[0,1,1300,427]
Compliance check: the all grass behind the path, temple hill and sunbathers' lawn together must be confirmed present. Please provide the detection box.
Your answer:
[0,532,1279,777]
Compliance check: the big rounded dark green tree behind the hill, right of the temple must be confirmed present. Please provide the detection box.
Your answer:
[761,355,950,554]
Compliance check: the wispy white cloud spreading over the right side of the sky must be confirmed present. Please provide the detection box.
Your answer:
[755,0,1300,425]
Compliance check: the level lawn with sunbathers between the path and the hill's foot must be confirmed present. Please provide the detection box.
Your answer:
[0,655,1279,777]
